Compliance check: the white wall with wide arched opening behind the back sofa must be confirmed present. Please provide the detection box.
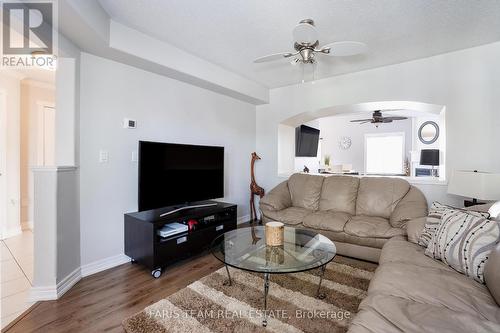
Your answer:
[257,42,500,203]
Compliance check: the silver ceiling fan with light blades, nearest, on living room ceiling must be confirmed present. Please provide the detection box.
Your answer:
[254,19,367,64]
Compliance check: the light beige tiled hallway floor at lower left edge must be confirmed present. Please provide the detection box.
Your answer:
[0,230,33,328]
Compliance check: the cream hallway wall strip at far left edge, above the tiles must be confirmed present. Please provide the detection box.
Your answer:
[0,72,21,237]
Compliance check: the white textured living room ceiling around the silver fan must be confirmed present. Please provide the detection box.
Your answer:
[99,0,500,88]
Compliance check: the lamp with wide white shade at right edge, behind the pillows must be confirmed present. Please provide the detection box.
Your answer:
[448,170,500,207]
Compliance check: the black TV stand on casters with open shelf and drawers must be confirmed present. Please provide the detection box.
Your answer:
[124,201,237,278]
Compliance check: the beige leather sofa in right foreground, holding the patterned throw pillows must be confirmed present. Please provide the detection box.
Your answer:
[349,239,500,333]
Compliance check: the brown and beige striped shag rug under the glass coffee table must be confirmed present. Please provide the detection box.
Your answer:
[123,256,377,333]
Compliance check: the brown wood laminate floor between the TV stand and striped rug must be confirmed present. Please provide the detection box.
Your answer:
[6,252,222,333]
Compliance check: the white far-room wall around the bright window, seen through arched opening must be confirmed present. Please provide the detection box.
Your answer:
[319,115,412,173]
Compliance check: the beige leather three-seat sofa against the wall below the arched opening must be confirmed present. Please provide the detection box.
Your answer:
[260,174,427,262]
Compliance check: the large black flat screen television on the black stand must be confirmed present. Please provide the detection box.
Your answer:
[138,141,224,211]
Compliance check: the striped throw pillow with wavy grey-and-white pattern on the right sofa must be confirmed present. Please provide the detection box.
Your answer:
[425,209,500,283]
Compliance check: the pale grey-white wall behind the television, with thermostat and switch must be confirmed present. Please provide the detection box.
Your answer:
[80,53,256,266]
